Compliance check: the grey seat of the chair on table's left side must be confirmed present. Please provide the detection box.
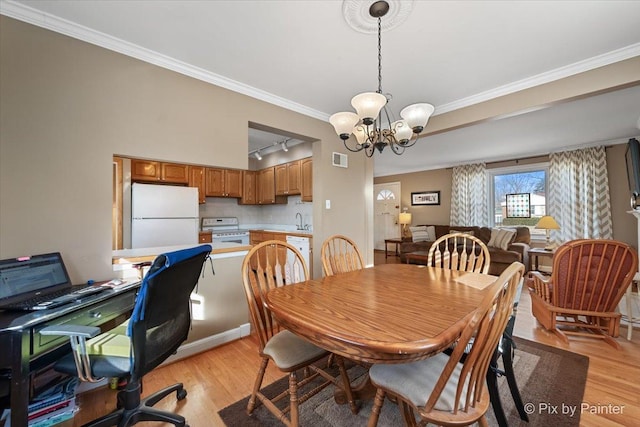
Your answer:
[263,330,328,372]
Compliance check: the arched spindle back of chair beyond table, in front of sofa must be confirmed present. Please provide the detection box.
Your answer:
[427,233,491,274]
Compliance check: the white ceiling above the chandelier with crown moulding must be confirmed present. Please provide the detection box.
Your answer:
[0,0,640,176]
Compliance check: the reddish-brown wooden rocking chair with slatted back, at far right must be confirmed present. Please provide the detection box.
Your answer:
[529,239,638,350]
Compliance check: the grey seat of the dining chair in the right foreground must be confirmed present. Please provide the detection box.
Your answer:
[369,353,466,411]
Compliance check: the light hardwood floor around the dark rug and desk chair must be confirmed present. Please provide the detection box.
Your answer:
[69,252,640,427]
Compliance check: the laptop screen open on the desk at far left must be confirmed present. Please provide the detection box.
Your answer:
[0,252,71,302]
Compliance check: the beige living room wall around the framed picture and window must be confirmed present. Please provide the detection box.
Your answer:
[374,145,638,248]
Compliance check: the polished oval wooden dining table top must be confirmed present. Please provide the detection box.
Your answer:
[265,264,496,363]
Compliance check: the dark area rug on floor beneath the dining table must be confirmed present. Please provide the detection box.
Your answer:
[218,337,589,427]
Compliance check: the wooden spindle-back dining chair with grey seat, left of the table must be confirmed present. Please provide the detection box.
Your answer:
[242,240,357,427]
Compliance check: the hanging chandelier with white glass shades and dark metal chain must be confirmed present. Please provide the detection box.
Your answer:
[329,1,434,157]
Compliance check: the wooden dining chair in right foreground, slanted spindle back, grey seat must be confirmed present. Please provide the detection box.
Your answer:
[368,262,524,427]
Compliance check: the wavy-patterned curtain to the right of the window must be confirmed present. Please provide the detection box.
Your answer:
[547,147,613,243]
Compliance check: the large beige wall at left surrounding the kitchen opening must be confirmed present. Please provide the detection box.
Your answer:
[0,16,373,281]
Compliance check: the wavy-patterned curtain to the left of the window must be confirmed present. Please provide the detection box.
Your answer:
[450,163,489,227]
